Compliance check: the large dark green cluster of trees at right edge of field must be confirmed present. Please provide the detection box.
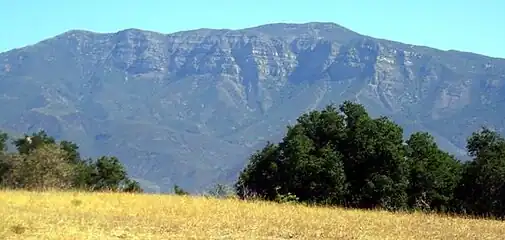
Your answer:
[235,101,505,218]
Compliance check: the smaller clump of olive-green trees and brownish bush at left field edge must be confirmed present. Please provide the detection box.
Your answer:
[0,131,143,192]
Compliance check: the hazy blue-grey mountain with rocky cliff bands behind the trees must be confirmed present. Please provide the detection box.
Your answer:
[0,23,505,192]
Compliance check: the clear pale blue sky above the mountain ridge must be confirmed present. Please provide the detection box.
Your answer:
[0,0,505,58]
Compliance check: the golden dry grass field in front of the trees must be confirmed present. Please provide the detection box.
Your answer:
[0,191,505,240]
